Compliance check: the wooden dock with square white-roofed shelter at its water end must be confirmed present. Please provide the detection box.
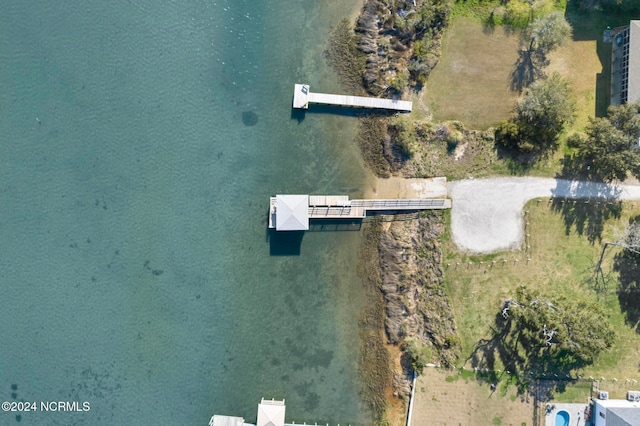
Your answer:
[269,195,451,231]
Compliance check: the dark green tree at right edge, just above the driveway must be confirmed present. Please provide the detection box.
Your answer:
[567,103,640,182]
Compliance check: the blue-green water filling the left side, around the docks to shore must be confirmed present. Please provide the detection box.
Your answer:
[0,0,368,425]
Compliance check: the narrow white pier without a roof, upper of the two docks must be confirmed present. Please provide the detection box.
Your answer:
[293,84,413,112]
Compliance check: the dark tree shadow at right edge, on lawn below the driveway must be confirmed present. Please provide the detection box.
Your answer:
[613,215,640,333]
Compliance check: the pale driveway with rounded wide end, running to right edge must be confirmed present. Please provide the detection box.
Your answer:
[448,177,640,253]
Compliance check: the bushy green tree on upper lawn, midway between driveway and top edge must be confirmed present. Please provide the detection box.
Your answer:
[496,73,575,155]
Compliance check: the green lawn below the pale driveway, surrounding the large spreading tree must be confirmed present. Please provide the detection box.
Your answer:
[443,200,640,396]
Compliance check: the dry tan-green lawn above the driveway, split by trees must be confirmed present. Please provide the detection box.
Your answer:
[424,0,631,176]
